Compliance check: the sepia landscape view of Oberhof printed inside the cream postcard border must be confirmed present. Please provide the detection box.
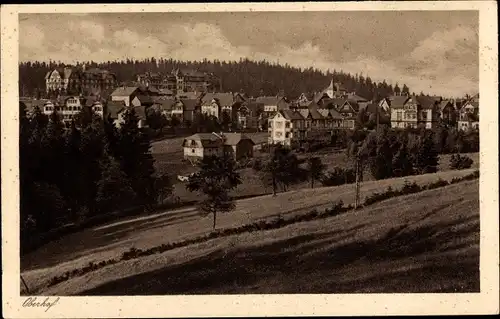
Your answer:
[2,2,498,316]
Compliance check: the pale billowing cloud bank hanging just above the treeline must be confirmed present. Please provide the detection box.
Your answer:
[20,20,479,96]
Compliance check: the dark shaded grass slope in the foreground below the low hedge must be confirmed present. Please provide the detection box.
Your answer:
[43,180,479,295]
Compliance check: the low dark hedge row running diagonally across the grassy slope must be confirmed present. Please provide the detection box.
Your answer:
[48,171,479,287]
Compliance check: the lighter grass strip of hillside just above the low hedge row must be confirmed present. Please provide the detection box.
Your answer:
[21,170,477,291]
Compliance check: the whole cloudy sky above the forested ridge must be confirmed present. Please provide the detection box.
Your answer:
[19,11,479,97]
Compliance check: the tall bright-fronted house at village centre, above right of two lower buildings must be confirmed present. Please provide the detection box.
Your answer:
[268,110,306,146]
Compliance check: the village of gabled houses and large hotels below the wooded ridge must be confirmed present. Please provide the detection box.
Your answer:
[20,66,479,164]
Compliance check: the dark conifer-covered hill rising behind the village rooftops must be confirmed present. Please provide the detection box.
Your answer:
[19,58,409,99]
